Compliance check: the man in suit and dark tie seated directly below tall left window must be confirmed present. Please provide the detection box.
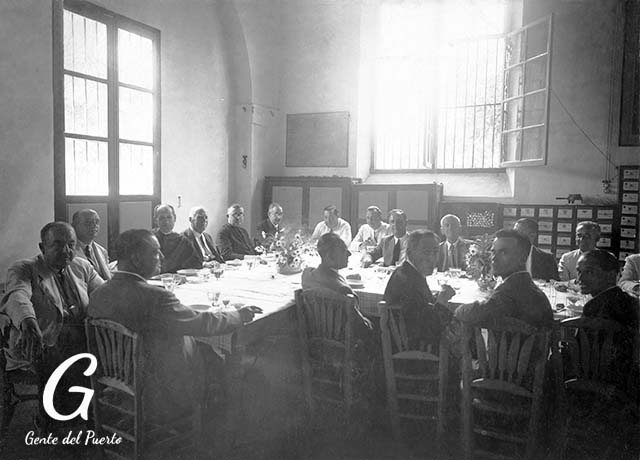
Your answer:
[71,209,111,280]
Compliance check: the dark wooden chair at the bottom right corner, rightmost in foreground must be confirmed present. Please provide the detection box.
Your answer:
[560,317,640,459]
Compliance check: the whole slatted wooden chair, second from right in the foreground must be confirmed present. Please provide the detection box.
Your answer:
[462,318,551,459]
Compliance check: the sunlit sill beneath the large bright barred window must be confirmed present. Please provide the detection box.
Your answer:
[364,169,513,201]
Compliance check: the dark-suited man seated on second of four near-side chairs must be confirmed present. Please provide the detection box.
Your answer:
[384,230,455,345]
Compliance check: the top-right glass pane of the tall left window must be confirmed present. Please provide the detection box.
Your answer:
[118,29,153,89]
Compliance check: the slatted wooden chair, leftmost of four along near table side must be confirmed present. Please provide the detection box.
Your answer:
[295,289,366,420]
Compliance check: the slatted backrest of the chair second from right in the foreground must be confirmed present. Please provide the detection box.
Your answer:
[463,317,551,397]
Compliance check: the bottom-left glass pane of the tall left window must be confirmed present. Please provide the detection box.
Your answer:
[65,137,109,196]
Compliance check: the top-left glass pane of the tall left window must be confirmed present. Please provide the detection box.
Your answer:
[63,10,107,78]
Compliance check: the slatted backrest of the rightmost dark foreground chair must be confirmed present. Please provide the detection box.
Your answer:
[560,317,632,384]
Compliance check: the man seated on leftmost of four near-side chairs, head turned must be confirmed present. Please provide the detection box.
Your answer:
[302,233,372,334]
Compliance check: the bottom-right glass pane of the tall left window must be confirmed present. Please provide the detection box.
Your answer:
[120,143,153,195]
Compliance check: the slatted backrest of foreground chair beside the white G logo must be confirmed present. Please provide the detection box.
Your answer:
[85,318,142,396]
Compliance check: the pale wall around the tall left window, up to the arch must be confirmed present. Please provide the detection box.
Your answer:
[0,0,239,278]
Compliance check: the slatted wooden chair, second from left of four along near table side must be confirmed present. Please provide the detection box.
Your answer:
[378,301,449,442]
